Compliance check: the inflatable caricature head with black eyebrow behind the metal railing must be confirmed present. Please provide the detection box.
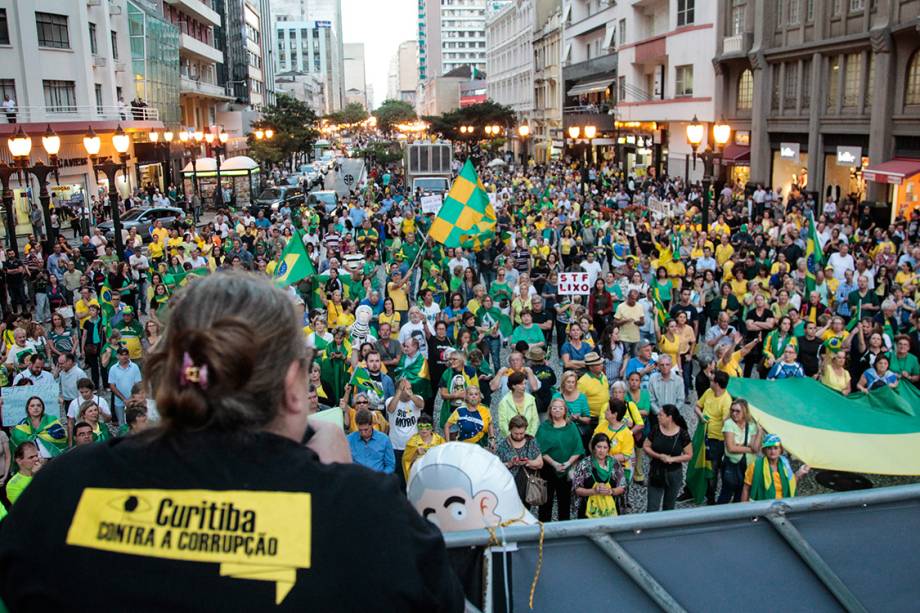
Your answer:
[408,443,536,532]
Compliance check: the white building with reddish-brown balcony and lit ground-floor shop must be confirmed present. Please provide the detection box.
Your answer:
[605,0,719,181]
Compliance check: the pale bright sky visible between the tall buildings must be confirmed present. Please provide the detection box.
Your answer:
[342,0,418,108]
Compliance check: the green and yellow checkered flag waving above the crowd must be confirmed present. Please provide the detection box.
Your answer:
[428,160,496,250]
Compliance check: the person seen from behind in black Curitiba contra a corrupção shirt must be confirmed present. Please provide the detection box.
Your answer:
[0,273,464,611]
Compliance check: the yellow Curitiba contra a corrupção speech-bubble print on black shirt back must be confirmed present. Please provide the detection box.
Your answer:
[67,487,311,604]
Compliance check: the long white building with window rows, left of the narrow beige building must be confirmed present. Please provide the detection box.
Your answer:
[486,0,536,161]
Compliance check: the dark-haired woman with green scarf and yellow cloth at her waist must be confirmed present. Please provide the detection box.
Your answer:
[572,433,626,519]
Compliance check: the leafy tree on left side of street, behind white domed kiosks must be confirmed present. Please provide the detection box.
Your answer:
[249,93,319,167]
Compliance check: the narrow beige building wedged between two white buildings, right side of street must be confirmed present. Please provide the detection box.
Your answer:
[528,1,565,163]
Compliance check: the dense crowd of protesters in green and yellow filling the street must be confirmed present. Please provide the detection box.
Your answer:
[0,139,920,521]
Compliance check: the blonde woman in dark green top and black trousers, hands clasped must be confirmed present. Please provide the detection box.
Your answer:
[537,396,585,522]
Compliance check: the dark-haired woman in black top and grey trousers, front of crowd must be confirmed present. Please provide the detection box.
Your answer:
[643,404,693,512]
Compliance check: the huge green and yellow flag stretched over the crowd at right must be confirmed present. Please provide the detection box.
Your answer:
[728,378,920,475]
